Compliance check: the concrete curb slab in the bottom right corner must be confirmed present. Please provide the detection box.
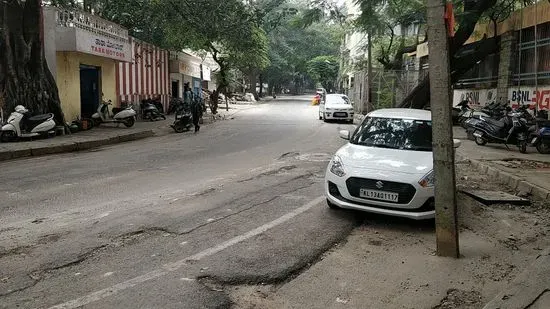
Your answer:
[483,249,550,309]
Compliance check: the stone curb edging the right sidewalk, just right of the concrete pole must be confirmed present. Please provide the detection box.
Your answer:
[456,152,550,200]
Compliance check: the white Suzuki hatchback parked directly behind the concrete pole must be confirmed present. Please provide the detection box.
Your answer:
[325,108,460,220]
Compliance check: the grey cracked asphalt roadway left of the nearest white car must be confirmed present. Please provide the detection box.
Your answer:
[0,97,361,308]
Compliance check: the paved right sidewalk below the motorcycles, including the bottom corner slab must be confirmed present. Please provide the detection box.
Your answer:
[454,127,550,309]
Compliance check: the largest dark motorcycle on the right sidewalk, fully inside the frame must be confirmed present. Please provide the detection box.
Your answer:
[466,106,529,153]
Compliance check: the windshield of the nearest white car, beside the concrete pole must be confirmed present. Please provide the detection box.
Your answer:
[350,117,432,151]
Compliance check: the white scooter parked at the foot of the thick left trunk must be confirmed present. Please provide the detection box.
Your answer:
[0,105,55,142]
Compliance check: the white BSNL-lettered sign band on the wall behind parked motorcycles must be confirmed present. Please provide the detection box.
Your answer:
[453,86,550,110]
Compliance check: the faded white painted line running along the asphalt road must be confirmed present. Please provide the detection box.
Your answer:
[49,196,325,309]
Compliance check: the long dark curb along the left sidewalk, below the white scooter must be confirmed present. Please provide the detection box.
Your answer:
[0,130,154,161]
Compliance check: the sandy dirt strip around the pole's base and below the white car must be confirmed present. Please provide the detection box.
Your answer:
[229,164,550,309]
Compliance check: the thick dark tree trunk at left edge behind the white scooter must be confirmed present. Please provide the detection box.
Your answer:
[0,0,65,125]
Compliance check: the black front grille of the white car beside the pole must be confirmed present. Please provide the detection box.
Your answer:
[346,177,416,204]
